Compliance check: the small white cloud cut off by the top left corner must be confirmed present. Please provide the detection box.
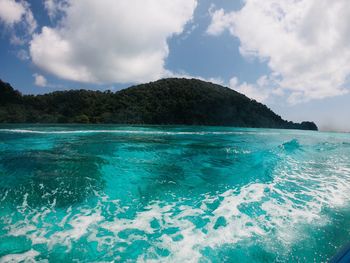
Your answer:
[0,0,37,42]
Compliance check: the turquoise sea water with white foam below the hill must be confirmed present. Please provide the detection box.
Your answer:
[0,125,350,262]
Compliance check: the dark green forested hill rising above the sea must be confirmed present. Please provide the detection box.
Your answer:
[0,78,317,130]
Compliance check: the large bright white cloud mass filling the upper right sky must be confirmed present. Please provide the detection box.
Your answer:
[207,0,350,103]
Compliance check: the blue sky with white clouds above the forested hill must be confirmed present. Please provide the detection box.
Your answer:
[0,0,350,131]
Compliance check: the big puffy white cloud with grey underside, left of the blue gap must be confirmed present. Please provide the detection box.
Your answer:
[30,0,197,83]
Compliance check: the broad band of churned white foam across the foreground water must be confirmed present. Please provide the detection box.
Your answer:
[2,147,350,262]
